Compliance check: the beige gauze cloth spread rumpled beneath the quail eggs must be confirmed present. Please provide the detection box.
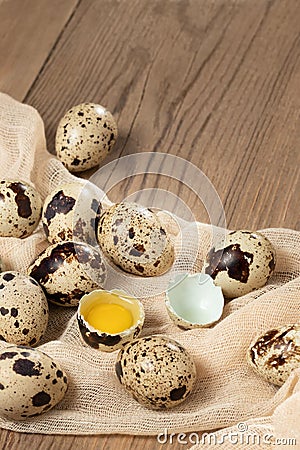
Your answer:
[0,94,300,442]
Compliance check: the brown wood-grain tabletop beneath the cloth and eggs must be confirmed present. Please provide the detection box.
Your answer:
[0,0,300,450]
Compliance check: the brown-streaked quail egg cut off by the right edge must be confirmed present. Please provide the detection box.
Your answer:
[247,324,300,386]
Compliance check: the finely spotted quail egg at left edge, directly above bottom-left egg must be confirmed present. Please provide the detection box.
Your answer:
[0,272,48,345]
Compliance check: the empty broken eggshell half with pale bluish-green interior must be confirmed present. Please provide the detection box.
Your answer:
[165,273,224,330]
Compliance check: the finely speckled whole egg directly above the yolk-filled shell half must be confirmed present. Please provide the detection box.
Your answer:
[98,202,174,276]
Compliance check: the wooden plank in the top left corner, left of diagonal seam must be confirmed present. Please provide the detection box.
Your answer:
[0,0,77,100]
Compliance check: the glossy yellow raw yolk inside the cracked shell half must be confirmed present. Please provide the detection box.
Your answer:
[86,303,133,334]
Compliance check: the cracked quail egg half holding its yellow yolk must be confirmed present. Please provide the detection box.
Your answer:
[77,290,145,352]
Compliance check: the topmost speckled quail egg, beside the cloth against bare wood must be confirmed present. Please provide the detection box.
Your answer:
[55,103,118,172]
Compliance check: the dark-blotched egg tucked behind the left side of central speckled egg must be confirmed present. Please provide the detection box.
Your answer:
[42,183,101,244]
